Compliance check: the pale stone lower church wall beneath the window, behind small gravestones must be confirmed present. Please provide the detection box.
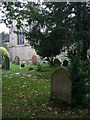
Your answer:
[9,45,40,63]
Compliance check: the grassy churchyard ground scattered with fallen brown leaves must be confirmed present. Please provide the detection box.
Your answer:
[2,64,90,118]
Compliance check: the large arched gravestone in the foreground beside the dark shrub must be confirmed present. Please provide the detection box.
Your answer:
[50,67,72,104]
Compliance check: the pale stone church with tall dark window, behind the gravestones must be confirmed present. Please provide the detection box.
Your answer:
[9,21,40,63]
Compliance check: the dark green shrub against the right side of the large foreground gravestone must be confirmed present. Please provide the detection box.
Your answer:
[69,57,89,105]
